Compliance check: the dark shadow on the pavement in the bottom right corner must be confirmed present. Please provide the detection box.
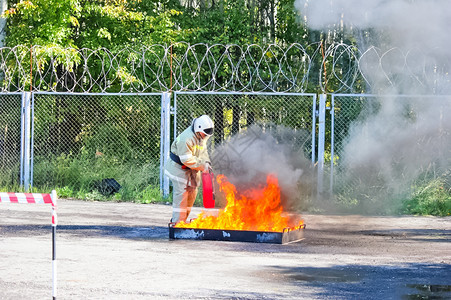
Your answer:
[267,263,451,300]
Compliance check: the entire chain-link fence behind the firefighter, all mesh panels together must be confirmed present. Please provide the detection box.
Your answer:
[0,92,451,207]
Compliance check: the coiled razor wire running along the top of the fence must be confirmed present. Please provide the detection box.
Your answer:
[0,42,450,93]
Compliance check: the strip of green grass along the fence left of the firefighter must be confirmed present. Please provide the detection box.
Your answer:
[27,154,168,203]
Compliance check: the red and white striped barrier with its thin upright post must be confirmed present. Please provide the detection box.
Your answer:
[0,190,58,299]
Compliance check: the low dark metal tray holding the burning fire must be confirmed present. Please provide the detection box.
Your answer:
[169,223,305,244]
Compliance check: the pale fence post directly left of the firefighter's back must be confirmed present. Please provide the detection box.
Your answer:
[160,92,171,197]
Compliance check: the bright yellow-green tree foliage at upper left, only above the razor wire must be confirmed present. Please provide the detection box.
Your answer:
[3,0,188,50]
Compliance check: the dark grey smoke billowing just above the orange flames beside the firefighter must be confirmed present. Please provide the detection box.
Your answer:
[211,124,312,209]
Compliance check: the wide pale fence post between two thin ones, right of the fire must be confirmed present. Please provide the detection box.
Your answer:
[316,94,327,199]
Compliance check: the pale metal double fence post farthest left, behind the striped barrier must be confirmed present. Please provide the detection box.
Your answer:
[20,92,31,192]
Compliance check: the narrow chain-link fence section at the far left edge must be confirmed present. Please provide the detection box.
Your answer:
[0,93,22,187]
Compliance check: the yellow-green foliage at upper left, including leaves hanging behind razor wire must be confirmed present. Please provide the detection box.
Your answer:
[3,0,190,91]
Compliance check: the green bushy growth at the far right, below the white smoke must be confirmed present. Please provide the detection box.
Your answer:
[402,178,451,216]
